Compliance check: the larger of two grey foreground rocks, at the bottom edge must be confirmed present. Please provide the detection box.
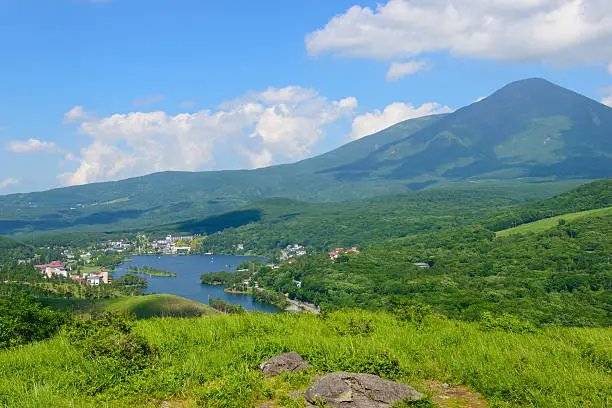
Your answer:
[305,372,423,408]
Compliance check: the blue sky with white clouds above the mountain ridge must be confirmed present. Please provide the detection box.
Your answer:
[0,0,612,194]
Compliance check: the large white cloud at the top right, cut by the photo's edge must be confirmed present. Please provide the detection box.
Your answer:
[306,0,612,70]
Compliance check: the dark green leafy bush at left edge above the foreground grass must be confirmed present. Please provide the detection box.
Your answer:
[0,293,67,349]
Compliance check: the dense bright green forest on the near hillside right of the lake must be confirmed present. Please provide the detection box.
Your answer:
[257,212,612,326]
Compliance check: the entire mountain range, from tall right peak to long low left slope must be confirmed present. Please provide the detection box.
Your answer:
[0,79,612,234]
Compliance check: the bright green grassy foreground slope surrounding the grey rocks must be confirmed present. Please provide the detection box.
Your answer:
[0,311,612,408]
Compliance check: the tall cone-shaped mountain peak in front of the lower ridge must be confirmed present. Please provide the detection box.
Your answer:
[324,79,612,182]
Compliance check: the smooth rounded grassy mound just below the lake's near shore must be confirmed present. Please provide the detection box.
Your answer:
[43,295,219,319]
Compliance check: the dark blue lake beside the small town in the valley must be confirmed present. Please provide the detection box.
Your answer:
[113,255,279,313]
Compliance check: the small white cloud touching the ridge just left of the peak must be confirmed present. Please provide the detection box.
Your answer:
[351,102,453,140]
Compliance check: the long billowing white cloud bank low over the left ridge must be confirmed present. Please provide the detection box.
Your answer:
[60,86,357,185]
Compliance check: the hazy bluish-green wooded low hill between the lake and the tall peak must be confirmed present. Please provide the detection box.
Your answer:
[202,185,580,254]
